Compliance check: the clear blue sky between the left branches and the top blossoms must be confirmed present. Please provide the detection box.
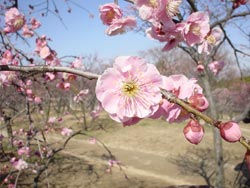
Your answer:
[19,0,160,58]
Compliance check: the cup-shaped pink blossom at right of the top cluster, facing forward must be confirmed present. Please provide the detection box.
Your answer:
[177,12,210,46]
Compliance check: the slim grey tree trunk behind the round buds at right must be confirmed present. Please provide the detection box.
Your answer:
[201,73,225,188]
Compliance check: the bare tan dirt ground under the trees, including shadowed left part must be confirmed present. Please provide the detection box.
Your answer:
[1,119,250,188]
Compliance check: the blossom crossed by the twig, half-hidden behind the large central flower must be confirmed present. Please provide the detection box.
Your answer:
[152,74,205,123]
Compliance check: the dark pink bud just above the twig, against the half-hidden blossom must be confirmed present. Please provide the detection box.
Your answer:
[188,93,209,112]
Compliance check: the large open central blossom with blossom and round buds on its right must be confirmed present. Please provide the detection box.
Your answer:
[96,56,241,144]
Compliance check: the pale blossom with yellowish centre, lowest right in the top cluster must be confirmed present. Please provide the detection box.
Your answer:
[198,27,222,54]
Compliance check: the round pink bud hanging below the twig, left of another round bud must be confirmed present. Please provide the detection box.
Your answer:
[183,120,204,144]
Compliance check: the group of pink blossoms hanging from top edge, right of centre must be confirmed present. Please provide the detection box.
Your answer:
[99,0,222,54]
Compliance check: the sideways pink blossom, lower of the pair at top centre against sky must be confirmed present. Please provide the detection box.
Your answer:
[106,16,136,36]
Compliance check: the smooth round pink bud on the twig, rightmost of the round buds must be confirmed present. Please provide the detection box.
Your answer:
[219,121,241,142]
